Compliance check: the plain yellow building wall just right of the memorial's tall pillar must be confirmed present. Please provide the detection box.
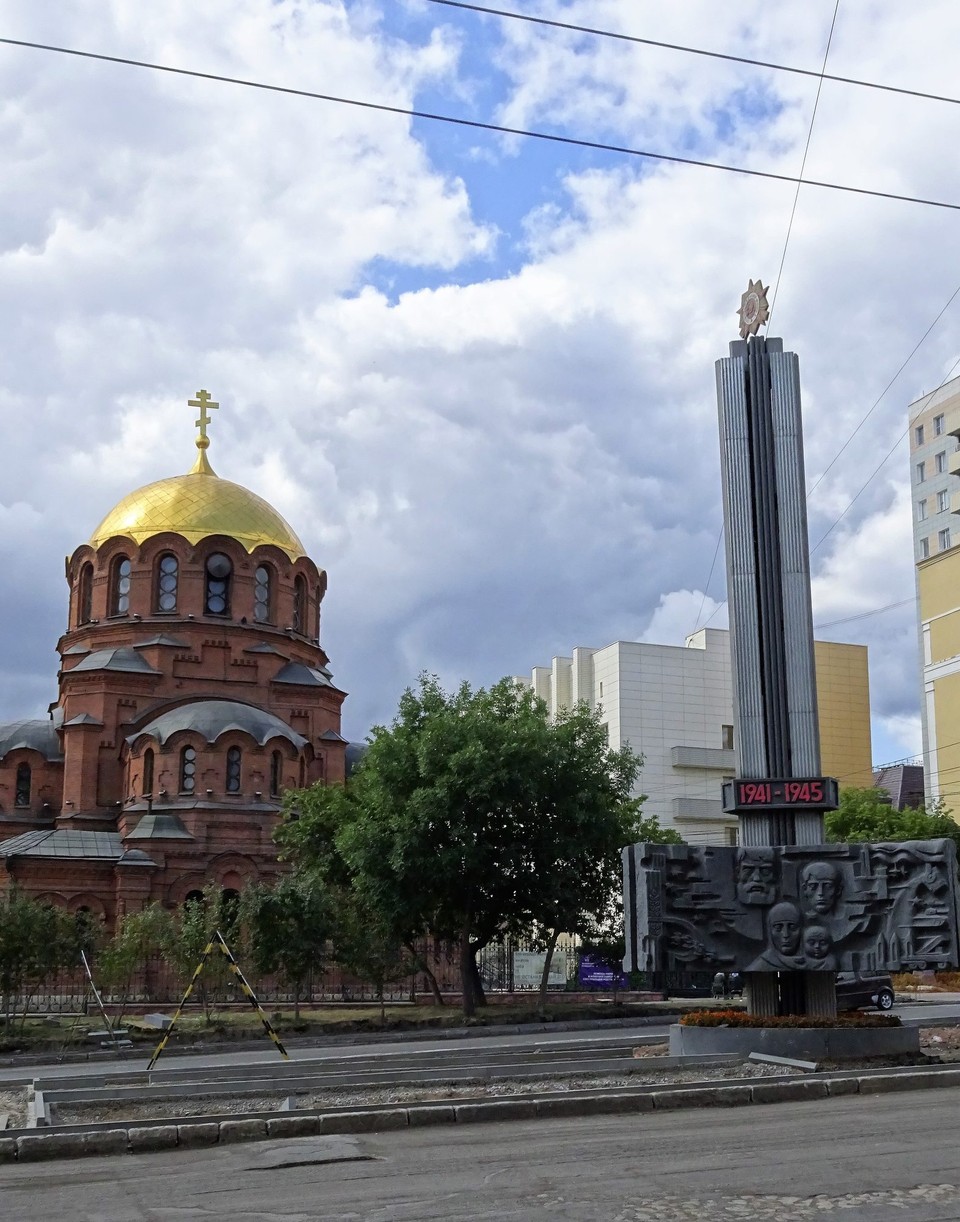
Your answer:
[813,640,869,788]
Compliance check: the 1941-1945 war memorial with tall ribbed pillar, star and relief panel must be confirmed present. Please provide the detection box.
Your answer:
[623,281,958,1018]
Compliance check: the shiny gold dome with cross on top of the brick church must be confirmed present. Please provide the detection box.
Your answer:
[90,391,307,560]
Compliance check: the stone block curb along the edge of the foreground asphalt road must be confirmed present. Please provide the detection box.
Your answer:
[0,1067,960,1163]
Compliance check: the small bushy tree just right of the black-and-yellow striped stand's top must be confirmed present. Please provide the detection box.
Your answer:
[241,875,332,1020]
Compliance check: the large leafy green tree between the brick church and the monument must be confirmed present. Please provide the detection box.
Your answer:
[336,676,641,1017]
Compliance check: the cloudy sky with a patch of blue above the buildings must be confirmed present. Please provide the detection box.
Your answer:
[0,0,960,763]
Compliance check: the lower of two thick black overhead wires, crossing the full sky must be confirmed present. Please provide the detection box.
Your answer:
[0,38,960,213]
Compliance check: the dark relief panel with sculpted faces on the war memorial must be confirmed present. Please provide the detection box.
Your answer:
[623,840,959,971]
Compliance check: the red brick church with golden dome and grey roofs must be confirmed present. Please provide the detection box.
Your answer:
[0,391,347,926]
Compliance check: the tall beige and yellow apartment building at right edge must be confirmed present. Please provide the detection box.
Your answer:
[910,378,960,810]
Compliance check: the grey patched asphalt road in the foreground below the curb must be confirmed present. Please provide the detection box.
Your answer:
[0,1091,960,1222]
